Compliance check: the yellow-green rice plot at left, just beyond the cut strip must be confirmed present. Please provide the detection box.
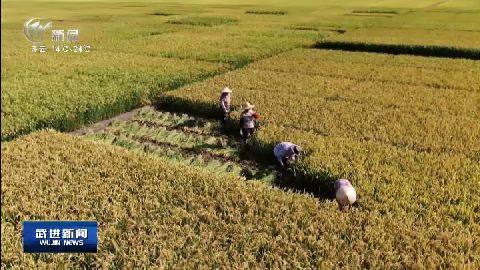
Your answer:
[2,53,228,140]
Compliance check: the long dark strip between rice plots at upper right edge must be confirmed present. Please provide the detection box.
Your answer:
[313,41,480,60]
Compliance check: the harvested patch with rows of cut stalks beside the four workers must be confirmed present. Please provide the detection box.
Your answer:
[78,107,276,184]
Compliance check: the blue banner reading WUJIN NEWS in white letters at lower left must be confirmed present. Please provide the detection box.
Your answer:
[23,221,98,253]
